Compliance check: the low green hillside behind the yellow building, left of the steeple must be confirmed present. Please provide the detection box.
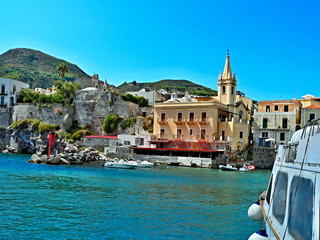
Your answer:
[118,79,217,96]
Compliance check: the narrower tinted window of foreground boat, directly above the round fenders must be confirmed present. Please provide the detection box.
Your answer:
[272,172,288,224]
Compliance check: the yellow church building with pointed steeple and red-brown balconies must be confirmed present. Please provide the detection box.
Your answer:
[153,54,251,151]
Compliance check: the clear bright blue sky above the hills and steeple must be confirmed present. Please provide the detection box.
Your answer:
[0,0,320,100]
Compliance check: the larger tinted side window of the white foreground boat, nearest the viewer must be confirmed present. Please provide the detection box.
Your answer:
[288,176,314,240]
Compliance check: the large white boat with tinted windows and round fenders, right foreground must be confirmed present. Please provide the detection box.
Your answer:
[248,119,320,240]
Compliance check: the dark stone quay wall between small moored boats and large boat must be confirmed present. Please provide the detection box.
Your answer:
[252,147,276,169]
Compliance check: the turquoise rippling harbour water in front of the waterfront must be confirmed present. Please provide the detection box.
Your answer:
[0,154,270,240]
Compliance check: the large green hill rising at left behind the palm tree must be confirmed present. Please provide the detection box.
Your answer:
[0,48,89,88]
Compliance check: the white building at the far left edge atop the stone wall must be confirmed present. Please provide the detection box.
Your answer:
[0,78,29,108]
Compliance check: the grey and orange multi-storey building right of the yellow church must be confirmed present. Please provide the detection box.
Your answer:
[253,99,302,147]
